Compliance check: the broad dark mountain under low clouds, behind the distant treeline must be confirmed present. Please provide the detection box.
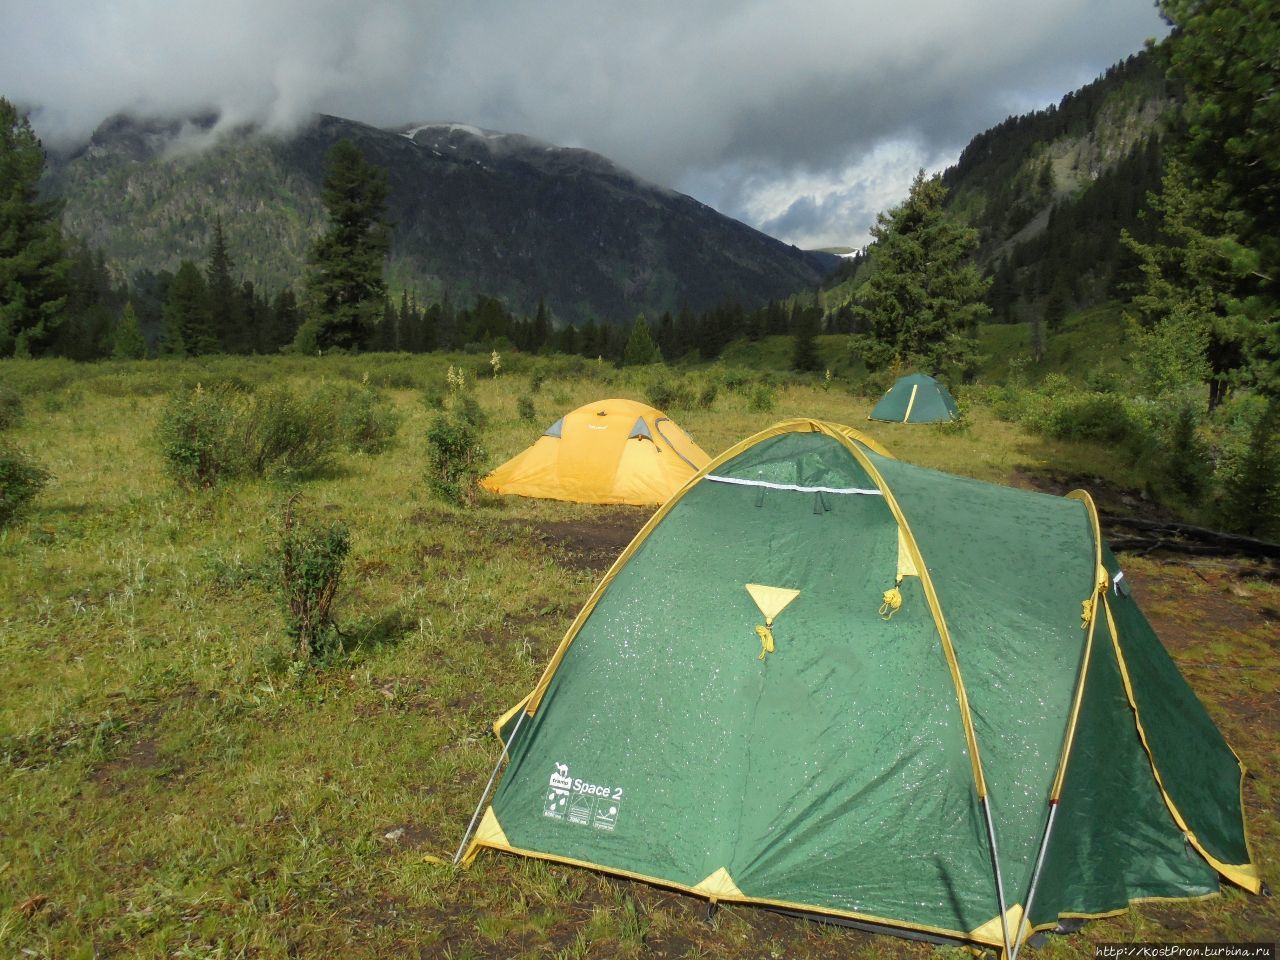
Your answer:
[47,116,838,323]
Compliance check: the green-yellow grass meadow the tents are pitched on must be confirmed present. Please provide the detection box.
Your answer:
[0,355,1280,960]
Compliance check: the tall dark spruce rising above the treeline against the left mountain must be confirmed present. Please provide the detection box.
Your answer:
[306,140,390,349]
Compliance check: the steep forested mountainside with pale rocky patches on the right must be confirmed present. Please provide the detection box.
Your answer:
[823,47,1181,321]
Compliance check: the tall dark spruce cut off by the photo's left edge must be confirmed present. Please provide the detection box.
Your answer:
[0,97,70,357]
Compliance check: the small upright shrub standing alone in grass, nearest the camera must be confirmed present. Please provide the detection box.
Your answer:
[279,498,351,659]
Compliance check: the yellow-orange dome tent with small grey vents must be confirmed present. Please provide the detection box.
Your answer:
[480,399,710,506]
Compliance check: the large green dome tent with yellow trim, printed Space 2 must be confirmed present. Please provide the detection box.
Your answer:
[458,420,1260,950]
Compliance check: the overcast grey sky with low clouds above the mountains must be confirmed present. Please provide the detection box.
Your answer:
[0,0,1166,247]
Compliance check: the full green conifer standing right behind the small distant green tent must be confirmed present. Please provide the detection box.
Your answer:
[854,170,991,372]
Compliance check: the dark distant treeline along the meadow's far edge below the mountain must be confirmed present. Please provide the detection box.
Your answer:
[38,218,829,362]
